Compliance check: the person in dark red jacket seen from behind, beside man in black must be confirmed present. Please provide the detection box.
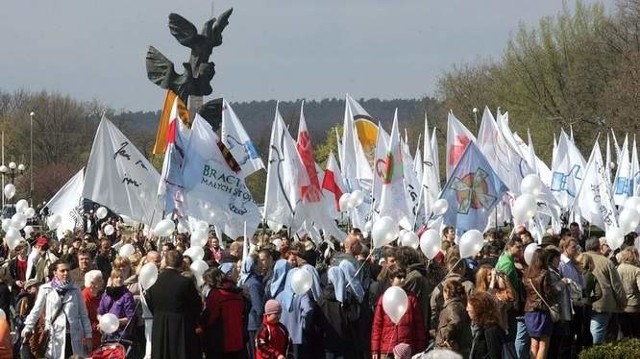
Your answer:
[201,267,246,359]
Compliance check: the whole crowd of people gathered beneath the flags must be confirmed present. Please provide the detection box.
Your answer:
[0,217,640,359]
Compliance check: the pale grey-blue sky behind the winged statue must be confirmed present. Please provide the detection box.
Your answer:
[0,0,615,111]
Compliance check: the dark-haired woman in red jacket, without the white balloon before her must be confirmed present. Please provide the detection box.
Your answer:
[371,264,427,359]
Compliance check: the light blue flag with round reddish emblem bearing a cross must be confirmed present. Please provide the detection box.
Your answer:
[440,142,508,235]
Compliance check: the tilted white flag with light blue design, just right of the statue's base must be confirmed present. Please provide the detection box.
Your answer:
[220,100,265,177]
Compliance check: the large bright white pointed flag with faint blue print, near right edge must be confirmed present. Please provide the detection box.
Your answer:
[574,140,617,231]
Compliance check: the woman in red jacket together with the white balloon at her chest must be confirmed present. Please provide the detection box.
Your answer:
[371,264,427,359]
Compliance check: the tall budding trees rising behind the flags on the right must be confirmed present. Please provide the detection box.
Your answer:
[438,0,640,163]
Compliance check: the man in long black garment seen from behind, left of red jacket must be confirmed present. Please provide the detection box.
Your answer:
[145,250,202,359]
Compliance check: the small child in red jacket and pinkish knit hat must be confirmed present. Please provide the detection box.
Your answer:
[255,299,289,359]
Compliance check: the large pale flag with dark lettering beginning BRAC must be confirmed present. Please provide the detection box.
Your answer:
[183,114,260,239]
